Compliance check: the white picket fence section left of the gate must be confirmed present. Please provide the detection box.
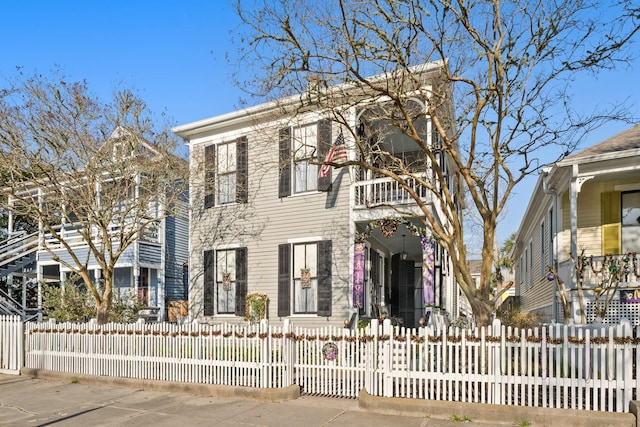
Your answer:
[25,322,293,388]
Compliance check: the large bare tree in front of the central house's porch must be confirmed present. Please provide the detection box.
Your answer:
[232,0,640,325]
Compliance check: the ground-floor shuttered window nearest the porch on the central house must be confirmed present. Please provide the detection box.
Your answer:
[278,240,332,317]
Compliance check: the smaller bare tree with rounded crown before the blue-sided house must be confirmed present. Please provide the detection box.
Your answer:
[0,72,188,323]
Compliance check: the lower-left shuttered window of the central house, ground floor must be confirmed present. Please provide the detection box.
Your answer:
[203,248,247,316]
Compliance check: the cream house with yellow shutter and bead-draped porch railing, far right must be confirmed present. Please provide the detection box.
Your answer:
[512,125,640,325]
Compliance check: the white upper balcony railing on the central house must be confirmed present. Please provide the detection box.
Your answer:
[354,177,429,208]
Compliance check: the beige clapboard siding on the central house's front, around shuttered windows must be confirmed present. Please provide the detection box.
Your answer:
[189,119,352,326]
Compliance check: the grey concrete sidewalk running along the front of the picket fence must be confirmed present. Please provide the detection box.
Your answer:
[0,374,635,427]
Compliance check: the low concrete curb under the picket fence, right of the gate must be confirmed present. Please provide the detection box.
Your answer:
[358,390,636,427]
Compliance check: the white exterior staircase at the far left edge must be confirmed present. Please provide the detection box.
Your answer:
[0,232,38,321]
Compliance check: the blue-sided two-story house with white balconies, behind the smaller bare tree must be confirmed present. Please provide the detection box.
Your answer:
[0,128,189,320]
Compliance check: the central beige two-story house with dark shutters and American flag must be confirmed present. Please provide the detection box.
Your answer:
[174,65,457,326]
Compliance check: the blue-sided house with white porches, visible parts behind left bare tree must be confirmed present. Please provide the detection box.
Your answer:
[0,129,189,320]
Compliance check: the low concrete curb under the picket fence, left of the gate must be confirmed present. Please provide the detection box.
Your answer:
[20,368,300,402]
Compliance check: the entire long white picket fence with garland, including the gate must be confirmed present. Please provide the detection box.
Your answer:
[6,320,640,412]
